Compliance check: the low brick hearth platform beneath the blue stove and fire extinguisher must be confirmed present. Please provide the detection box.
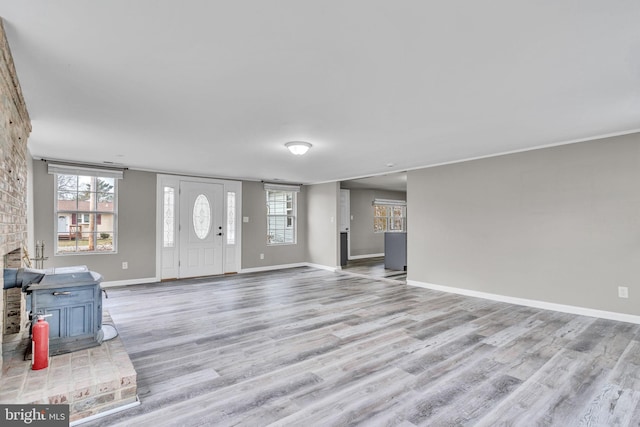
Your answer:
[0,311,137,422]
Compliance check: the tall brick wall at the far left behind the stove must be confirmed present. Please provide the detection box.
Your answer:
[0,19,31,364]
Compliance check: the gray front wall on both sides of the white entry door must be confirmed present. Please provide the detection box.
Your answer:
[33,164,318,281]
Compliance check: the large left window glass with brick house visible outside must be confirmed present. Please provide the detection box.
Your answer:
[55,174,117,254]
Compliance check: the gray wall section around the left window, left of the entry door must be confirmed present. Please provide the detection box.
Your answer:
[31,160,156,281]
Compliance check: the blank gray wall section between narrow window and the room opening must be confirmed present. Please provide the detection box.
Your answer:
[307,182,340,267]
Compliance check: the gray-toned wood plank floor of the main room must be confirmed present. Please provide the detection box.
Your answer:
[85,267,640,427]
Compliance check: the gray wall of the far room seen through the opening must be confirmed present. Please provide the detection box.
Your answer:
[349,189,407,256]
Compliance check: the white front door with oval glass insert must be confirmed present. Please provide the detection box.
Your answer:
[179,181,224,278]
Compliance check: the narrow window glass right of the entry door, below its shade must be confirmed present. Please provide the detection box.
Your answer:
[267,190,296,245]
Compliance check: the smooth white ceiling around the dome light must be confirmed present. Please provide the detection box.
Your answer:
[0,0,640,183]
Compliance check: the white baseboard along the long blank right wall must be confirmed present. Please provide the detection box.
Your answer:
[407,280,640,324]
